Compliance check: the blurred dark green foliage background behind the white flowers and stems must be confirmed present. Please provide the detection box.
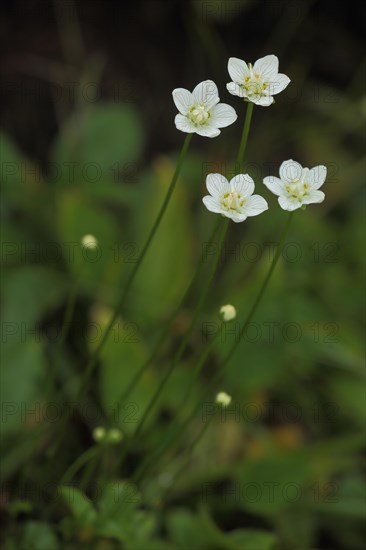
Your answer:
[0,0,365,550]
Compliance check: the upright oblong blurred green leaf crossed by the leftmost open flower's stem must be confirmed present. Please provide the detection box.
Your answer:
[133,160,194,322]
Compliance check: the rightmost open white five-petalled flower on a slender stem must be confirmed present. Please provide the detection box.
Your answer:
[263,159,327,211]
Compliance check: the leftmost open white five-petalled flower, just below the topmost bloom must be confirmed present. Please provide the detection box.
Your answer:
[173,80,238,137]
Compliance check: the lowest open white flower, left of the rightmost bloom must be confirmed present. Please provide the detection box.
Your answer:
[202,174,268,223]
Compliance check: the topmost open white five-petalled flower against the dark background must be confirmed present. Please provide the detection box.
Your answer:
[226,55,291,107]
